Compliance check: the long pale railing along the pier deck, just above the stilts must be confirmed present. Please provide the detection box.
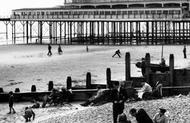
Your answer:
[11,13,182,20]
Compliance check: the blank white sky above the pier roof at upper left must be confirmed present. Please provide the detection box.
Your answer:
[0,0,64,17]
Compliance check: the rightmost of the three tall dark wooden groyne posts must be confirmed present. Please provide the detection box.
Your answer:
[169,54,174,86]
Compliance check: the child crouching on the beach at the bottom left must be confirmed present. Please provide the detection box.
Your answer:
[24,107,35,122]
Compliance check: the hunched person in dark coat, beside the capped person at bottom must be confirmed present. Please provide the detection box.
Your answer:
[129,108,153,123]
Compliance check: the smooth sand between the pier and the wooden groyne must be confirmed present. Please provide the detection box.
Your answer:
[0,45,190,92]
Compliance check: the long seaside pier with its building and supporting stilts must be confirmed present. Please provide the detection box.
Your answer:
[7,0,190,45]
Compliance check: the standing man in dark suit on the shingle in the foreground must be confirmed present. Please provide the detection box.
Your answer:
[111,81,126,123]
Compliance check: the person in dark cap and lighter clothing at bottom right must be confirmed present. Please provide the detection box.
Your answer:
[153,108,168,123]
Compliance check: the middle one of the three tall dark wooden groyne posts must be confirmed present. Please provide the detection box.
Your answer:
[145,53,150,83]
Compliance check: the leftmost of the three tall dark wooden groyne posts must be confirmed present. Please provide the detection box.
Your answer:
[125,52,131,81]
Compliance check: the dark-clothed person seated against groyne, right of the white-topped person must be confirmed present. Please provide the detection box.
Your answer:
[152,81,162,98]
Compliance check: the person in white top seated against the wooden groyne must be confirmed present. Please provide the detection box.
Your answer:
[138,82,152,99]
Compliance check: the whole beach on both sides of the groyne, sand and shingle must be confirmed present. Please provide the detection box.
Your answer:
[0,45,190,123]
